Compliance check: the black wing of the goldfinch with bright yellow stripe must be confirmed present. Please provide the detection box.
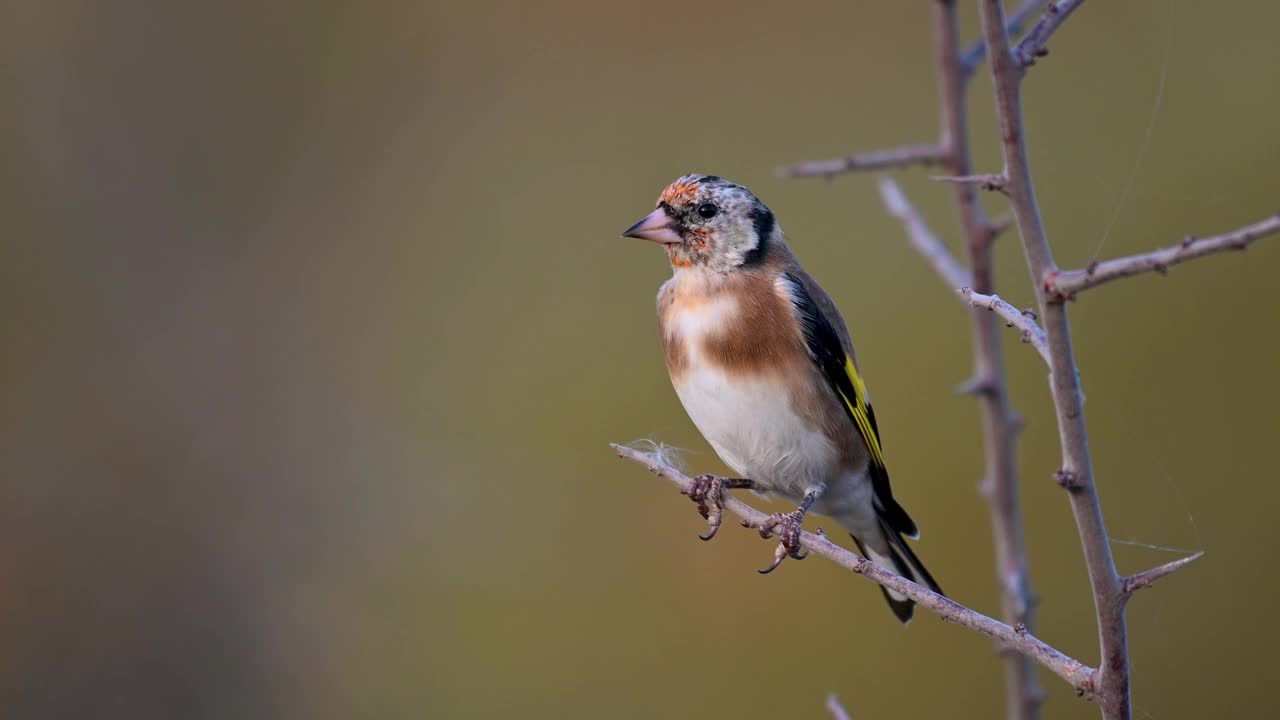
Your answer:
[786,266,919,537]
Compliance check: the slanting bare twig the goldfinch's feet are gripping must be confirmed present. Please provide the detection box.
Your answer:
[611,445,1094,697]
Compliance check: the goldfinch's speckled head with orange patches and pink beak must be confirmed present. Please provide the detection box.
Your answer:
[622,174,777,272]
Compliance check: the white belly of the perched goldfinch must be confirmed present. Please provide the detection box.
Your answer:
[676,361,838,497]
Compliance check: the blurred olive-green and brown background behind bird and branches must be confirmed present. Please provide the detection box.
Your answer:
[0,0,1280,719]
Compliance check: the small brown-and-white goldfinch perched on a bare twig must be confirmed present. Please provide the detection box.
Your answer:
[622,173,942,624]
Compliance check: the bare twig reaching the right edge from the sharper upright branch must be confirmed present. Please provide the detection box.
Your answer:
[1044,213,1280,300]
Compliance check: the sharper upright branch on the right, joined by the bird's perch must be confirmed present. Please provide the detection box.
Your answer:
[979,0,1130,720]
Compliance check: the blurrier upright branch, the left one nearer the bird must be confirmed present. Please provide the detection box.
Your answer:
[933,0,1043,720]
